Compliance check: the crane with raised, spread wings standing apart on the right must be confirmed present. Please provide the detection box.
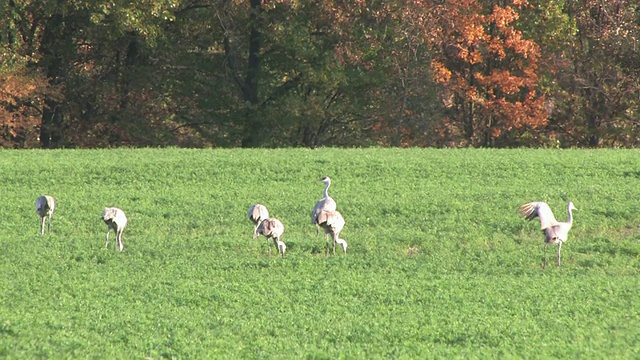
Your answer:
[518,201,578,267]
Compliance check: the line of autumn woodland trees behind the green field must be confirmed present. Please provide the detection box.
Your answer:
[0,0,640,148]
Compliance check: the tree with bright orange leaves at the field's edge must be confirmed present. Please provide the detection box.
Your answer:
[430,0,547,146]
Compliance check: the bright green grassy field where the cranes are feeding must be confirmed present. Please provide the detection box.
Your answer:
[0,149,640,359]
